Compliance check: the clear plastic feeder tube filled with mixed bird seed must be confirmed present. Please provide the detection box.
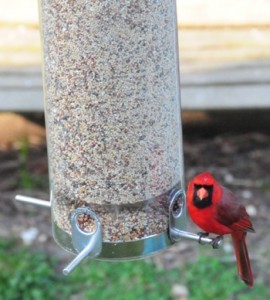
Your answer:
[40,0,183,259]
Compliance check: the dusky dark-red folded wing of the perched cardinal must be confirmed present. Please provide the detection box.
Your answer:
[216,187,254,232]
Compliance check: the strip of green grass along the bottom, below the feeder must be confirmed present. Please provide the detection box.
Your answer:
[0,240,270,300]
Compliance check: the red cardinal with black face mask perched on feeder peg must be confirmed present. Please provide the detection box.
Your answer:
[187,172,255,287]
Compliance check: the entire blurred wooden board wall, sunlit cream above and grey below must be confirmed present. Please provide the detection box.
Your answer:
[0,0,270,111]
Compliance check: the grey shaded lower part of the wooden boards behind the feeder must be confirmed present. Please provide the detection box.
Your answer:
[0,60,270,111]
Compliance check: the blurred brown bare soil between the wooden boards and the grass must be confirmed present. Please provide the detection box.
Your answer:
[0,111,270,283]
